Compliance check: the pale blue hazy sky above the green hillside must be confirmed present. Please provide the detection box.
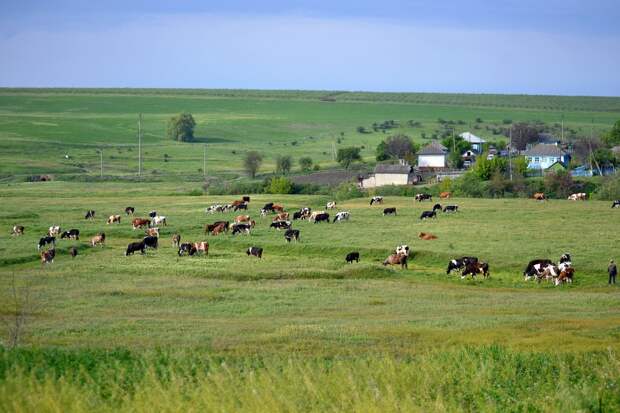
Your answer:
[0,0,620,96]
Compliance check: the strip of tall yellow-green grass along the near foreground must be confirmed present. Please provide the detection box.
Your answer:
[0,346,620,412]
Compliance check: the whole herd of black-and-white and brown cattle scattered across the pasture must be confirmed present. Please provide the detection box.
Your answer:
[12,192,620,285]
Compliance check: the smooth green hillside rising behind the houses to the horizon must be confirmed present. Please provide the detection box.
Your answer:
[0,89,620,181]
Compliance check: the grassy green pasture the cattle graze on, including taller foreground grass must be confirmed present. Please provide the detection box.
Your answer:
[0,182,620,411]
